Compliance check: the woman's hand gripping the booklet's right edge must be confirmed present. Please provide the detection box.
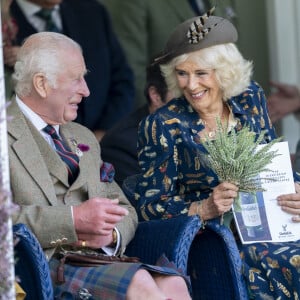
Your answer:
[277,183,300,222]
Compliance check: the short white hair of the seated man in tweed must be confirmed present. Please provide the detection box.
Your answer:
[12,32,82,96]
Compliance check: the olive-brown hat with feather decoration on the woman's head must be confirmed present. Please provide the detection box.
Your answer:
[155,9,238,64]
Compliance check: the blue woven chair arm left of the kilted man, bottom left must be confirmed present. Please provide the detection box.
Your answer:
[13,224,53,300]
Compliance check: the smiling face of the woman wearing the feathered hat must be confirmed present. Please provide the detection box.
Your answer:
[175,59,222,113]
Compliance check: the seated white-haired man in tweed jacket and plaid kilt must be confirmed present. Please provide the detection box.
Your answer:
[7,32,190,299]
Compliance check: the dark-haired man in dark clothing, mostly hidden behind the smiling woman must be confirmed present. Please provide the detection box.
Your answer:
[100,64,172,186]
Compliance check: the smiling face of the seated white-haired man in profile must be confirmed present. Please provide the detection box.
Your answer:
[38,48,90,125]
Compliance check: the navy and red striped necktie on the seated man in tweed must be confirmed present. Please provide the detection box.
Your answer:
[43,125,79,185]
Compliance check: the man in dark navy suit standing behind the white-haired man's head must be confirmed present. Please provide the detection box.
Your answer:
[3,0,134,140]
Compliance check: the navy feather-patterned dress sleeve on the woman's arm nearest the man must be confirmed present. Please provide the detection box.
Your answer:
[135,115,189,220]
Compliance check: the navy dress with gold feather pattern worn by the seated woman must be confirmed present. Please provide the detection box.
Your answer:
[135,82,300,299]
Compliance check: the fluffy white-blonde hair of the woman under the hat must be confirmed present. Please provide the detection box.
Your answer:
[160,43,253,101]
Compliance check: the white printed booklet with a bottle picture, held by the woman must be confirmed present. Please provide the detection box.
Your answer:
[232,142,300,244]
